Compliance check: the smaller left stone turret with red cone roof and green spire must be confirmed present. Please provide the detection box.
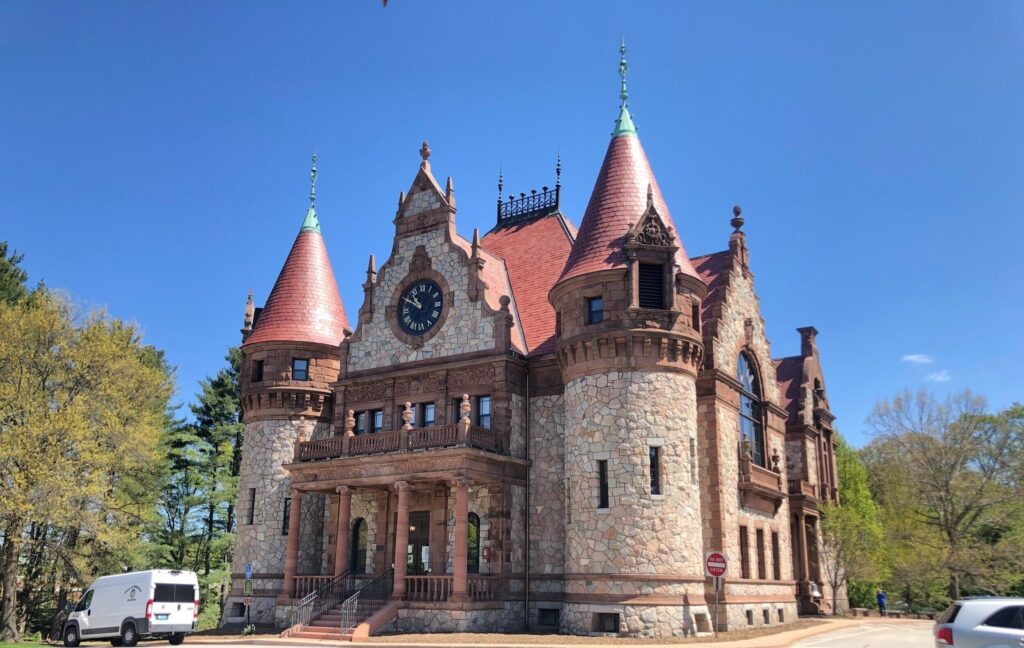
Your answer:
[224,154,351,623]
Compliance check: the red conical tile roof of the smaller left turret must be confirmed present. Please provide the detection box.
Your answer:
[245,231,348,345]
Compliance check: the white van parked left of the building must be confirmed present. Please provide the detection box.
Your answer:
[63,569,199,646]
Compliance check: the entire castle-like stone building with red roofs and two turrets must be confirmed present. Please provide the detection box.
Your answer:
[224,48,838,637]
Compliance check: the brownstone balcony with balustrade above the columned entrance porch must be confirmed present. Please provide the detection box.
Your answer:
[295,423,506,462]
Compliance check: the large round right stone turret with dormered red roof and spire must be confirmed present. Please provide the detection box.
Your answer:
[549,45,707,636]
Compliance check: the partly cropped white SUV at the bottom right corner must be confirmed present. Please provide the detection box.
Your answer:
[935,597,1024,648]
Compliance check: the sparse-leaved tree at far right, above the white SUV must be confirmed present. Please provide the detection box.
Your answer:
[865,391,1024,599]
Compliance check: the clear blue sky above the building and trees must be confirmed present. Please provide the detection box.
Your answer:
[0,0,1024,444]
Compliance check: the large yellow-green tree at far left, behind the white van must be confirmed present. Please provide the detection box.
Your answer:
[0,289,173,641]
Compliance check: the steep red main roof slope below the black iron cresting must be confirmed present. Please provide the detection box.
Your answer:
[480,214,574,355]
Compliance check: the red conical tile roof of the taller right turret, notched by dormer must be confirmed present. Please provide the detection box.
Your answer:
[560,135,697,280]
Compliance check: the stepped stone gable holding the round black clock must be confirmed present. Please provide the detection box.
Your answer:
[341,142,525,378]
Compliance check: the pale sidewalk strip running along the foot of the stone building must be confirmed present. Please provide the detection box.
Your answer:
[187,617,927,648]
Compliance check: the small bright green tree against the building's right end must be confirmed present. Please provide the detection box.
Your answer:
[821,437,883,614]
